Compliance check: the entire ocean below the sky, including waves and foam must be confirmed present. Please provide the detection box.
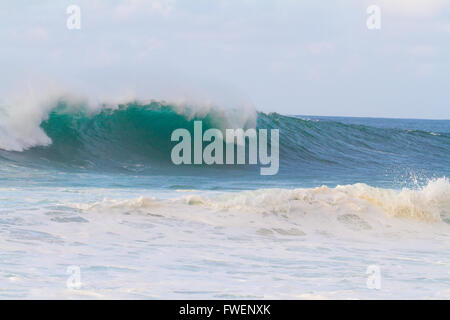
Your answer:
[0,100,450,299]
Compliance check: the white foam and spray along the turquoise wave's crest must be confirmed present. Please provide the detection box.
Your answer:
[0,84,257,151]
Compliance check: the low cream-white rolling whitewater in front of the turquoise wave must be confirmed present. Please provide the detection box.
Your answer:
[72,177,450,232]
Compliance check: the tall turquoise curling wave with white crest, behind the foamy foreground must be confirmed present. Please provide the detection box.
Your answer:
[0,99,450,182]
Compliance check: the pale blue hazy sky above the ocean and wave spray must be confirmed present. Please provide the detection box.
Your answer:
[0,0,450,119]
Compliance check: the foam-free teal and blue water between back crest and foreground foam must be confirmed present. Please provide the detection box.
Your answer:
[0,103,450,190]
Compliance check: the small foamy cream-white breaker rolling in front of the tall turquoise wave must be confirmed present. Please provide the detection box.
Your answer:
[77,178,450,224]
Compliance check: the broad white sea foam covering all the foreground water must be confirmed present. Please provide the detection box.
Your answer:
[0,178,450,299]
